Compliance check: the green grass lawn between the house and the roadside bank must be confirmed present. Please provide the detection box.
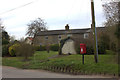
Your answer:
[2,51,118,74]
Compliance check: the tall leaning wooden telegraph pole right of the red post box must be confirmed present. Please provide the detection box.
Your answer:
[91,0,98,63]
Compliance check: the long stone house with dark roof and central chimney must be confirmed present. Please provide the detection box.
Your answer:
[33,24,104,45]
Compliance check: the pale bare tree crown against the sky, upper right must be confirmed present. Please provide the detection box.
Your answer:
[103,2,120,26]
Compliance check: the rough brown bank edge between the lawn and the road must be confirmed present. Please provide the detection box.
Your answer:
[40,66,120,77]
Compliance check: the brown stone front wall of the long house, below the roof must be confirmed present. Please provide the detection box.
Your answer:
[33,34,89,45]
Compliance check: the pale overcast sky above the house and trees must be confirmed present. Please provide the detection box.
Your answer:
[0,0,105,39]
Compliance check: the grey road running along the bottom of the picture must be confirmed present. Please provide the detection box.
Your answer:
[2,66,111,78]
